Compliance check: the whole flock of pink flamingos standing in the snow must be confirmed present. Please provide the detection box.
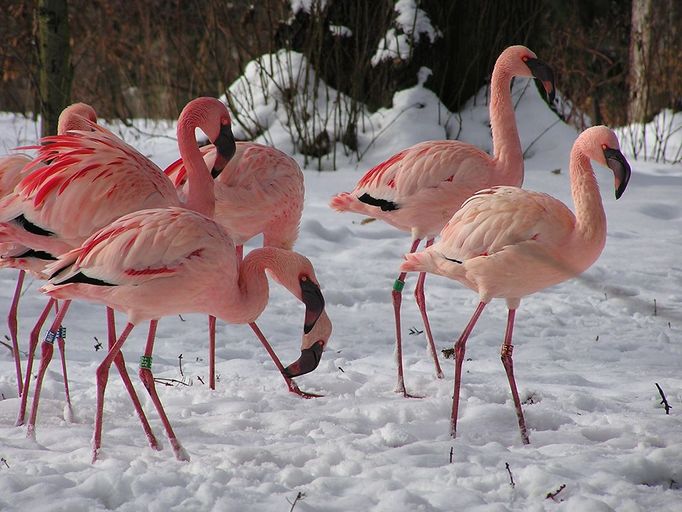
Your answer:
[0,46,630,462]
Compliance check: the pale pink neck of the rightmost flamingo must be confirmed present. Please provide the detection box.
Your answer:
[570,147,606,250]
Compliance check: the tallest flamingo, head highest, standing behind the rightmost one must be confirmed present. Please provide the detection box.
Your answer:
[330,46,554,397]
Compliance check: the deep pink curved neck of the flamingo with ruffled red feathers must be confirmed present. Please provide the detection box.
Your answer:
[178,120,215,218]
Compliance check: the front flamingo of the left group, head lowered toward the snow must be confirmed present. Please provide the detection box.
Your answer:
[39,207,331,462]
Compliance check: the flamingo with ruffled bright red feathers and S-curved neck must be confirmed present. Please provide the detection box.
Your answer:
[0,98,234,432]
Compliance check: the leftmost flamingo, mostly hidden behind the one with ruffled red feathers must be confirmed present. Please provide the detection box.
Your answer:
[0,103,97,396]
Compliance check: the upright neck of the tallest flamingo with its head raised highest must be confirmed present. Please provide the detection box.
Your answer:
[490,65,523,187]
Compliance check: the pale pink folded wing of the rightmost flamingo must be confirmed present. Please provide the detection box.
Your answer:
[437,187,575,261]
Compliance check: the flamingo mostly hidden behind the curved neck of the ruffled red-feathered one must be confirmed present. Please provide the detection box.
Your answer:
[164,142,305,389]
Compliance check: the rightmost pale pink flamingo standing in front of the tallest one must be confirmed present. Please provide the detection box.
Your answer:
[400,126,630,444]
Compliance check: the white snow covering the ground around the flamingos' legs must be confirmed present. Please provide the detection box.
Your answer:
[0,67,682,512]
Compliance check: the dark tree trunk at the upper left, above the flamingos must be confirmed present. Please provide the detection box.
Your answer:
[38,0,73,137]
